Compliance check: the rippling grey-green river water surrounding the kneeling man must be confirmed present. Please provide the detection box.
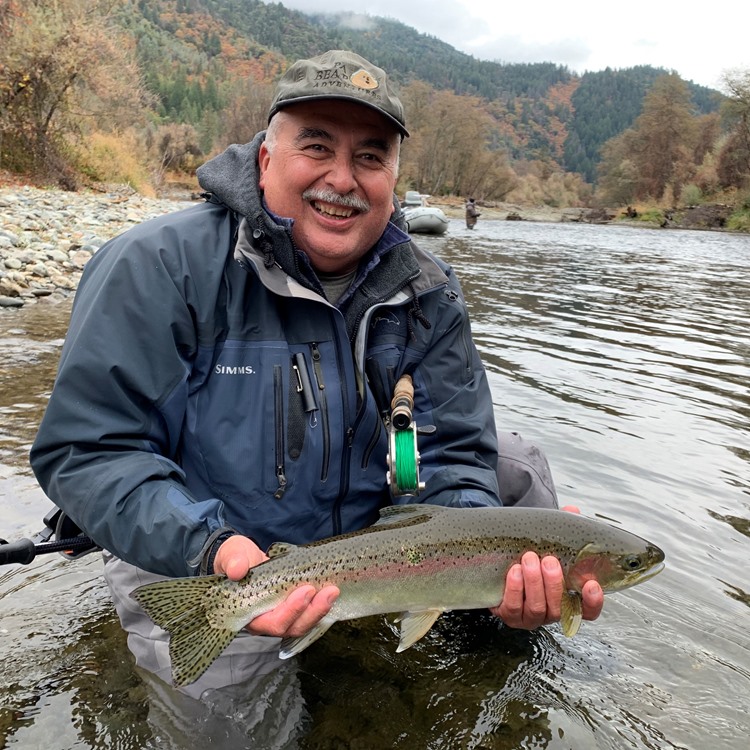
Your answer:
[0,214,750,750]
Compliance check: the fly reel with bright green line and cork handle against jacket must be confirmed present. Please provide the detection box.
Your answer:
[386,375,425,497]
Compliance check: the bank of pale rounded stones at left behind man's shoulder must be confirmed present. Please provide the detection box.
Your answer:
[0,186,190,307]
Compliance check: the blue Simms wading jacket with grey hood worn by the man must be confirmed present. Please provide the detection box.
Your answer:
[31,134,500,576]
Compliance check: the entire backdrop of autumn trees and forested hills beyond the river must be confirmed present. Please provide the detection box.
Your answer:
[0,0,750,217]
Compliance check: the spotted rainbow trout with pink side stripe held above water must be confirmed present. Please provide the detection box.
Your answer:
[132,503,664,687]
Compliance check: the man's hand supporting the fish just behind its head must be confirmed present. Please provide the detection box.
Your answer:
[490,505,604,630]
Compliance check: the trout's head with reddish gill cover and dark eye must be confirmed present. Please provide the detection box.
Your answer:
[565,535,664,592]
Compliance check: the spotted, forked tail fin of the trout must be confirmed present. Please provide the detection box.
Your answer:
[132,576,237,687]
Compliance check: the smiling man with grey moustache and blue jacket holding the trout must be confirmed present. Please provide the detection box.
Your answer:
[31,51,602,695]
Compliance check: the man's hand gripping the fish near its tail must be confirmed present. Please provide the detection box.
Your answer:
[214,535,339,638]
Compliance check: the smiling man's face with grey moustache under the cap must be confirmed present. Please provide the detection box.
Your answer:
[259,100,400,273]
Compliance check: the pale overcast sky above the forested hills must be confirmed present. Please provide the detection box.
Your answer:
[281,0,750,89]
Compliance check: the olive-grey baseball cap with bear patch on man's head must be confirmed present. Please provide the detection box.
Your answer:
[268,49,409,137]
